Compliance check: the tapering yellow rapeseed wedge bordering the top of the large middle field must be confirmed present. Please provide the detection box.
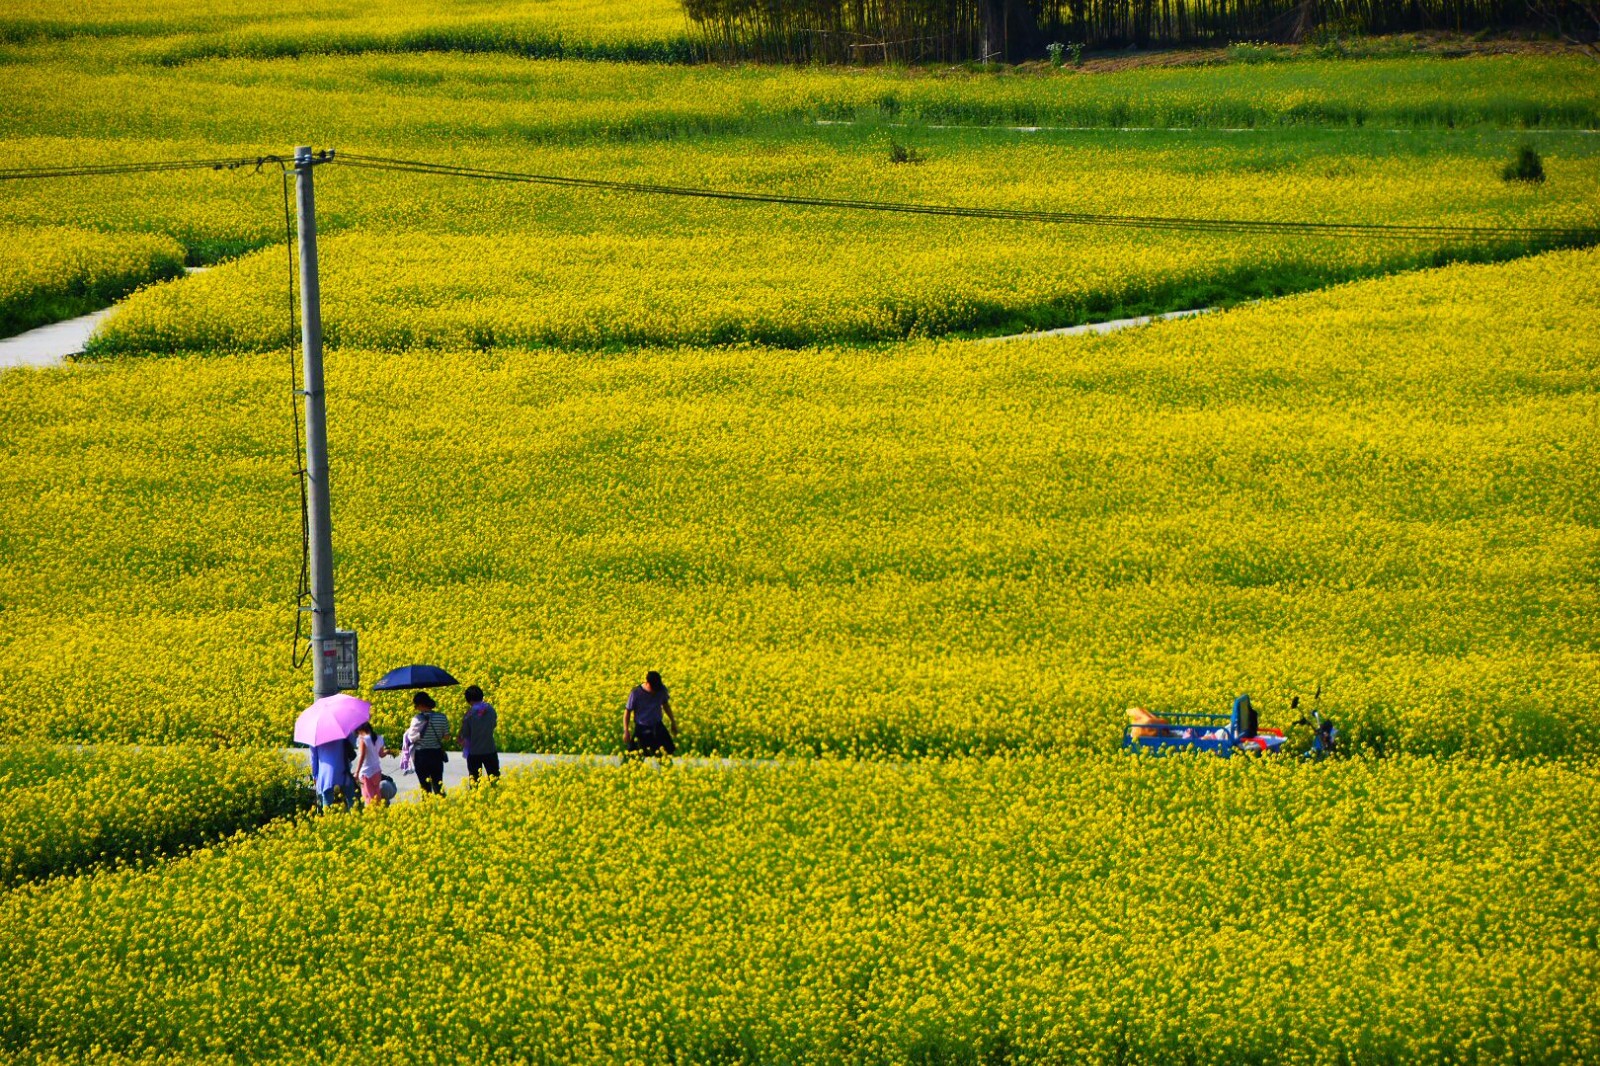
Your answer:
[81,221,1568,355]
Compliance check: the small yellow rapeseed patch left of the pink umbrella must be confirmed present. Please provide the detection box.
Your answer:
[0,744,310,888]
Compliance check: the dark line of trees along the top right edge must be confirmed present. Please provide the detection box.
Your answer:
[683,0,1595,62]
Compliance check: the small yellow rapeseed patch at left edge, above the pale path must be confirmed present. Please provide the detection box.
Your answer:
[0,226,184,336]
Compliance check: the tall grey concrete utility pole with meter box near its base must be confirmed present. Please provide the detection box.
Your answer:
[294,146,360,699]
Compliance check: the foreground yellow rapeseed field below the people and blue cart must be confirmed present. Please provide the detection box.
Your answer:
[0,755,1600,1066]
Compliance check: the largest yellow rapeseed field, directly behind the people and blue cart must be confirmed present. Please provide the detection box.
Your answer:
[0,251,1600,755]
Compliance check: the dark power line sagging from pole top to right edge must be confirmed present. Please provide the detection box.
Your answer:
[334,154,1600,243]
